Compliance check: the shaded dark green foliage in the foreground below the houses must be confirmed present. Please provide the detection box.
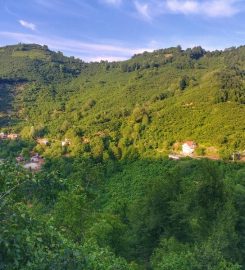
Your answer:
[0,157,245,270]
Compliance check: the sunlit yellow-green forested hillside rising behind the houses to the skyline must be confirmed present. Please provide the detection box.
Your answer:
[0,44,245,159]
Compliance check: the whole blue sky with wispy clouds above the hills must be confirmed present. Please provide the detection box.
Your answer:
[0,0,245,61]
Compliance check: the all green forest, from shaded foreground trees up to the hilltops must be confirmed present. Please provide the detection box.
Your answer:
[0,44,245,270]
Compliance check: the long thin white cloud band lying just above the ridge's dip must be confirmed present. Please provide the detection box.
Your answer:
[0,32,153,61]
